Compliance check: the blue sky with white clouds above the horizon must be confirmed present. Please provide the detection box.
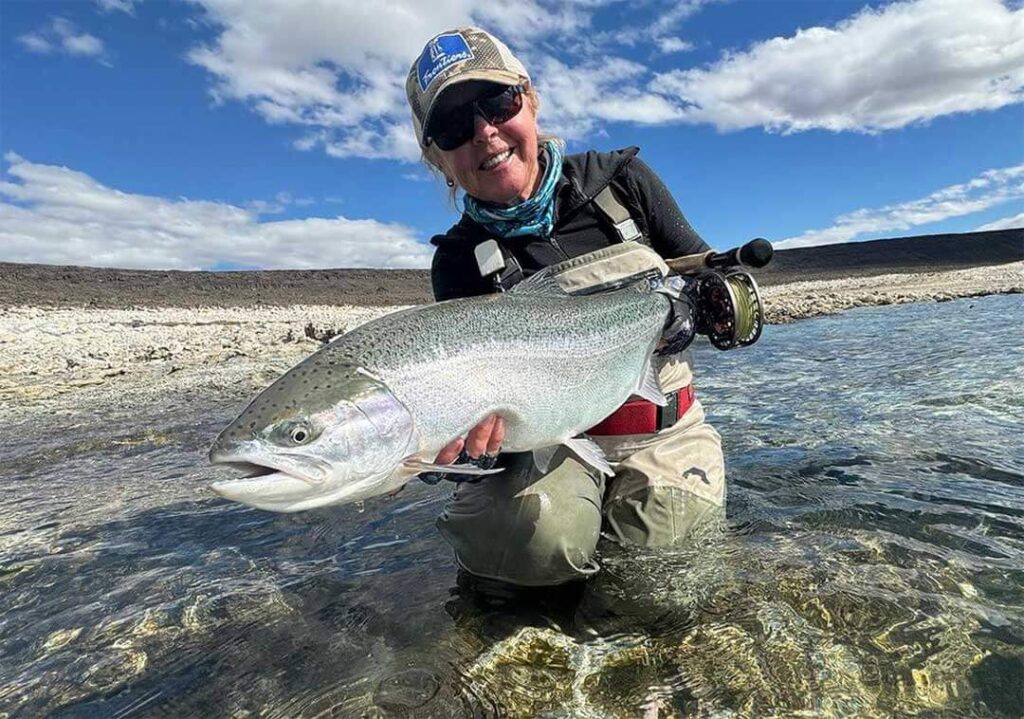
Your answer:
[0,0,1024,269]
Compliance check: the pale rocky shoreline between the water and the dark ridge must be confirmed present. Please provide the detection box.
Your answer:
[0,262,1024,422]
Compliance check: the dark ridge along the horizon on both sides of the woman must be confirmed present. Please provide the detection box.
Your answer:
[0,228,1024,307]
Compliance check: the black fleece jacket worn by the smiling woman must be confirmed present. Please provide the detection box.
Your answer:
[430,147,711,300]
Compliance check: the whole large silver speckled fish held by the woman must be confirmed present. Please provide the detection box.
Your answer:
[210,274,670,512]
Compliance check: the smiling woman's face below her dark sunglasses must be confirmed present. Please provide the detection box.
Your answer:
[439,91,540,205]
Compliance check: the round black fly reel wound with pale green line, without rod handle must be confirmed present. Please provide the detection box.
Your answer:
[696,270,764,349]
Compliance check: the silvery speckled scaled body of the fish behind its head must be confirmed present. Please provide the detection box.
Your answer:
[333,291,668,452]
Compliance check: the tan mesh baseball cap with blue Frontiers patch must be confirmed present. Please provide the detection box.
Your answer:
[406,27,529,146]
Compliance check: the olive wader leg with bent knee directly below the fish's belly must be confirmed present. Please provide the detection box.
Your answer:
[437,449,604,586]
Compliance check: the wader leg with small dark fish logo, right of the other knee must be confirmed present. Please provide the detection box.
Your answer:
[599,401,725,547]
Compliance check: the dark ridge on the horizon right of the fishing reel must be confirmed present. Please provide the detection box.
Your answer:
[754,228,1024,285]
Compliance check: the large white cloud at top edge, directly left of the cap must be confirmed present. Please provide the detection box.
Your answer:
[183,0,470,161]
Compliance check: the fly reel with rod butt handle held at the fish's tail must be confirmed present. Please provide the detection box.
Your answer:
[659,239,773,354]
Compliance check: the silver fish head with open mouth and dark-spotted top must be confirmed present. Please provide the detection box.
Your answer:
[210,362,415,512]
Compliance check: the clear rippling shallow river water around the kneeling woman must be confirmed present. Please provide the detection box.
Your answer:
[0,296,1024,717]
